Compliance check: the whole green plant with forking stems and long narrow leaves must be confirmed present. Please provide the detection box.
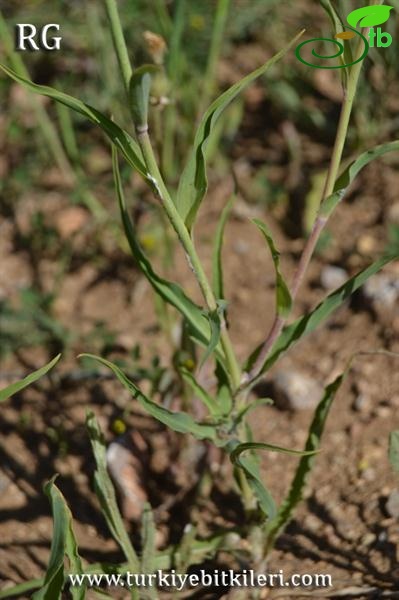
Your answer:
[0,0,399,600]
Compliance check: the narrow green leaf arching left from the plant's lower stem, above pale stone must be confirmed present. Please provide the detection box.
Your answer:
[81,354,216,442]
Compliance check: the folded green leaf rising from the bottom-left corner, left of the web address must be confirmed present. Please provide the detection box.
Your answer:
[32,477,86,600]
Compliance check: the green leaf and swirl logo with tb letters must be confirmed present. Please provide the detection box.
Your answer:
[295,5,393,69]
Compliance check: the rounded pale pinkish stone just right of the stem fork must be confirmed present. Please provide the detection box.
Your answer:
[274,370,323,411]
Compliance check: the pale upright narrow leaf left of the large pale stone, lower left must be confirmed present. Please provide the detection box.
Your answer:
[86,413,140,573]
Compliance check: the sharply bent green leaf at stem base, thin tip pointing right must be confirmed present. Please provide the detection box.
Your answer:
[230,442,314,519]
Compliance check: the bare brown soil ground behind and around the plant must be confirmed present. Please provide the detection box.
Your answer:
[0,23,399,598]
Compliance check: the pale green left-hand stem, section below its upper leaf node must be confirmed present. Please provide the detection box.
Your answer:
[137,127,241,388]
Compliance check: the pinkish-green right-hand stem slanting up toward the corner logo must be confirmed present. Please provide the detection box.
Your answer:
[241,34,363,388]
